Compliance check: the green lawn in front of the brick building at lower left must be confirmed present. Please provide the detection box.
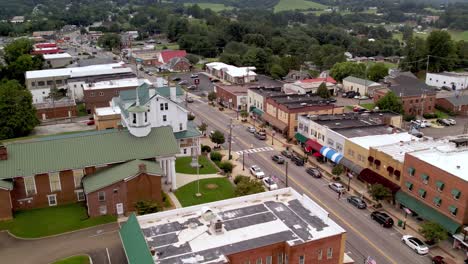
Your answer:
[0,204,116,238]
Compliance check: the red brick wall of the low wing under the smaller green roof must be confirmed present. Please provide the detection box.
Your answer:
[87,174,162,217]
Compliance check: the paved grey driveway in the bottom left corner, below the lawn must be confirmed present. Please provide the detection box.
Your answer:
[0,223,127,264]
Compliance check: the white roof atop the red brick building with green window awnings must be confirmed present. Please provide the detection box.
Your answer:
[409,143,468,181]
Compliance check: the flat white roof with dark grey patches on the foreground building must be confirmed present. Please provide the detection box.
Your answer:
[137,188,345,264]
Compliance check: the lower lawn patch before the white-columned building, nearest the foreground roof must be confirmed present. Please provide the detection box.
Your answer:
[175,178,234,207]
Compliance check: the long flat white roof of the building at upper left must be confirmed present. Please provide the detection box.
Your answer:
[26,62,125,79]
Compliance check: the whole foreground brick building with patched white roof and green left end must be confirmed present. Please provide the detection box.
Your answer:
[119,188,349,264]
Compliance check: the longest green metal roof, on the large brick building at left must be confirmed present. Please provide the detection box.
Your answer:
[0,126,180,178]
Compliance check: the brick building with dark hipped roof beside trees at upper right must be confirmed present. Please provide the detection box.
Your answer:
[374,72,436,115]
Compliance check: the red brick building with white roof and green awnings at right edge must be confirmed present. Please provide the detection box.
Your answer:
[396,136,468,234]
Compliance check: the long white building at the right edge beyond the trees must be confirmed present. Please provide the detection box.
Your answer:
[426,72,468,90]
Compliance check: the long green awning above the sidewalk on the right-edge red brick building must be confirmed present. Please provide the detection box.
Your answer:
[395,191,461,234]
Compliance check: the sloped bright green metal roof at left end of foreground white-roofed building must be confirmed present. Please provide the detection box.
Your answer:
[119,214,154,264]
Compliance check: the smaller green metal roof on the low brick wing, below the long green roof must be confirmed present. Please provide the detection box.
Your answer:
[83,160,162,194]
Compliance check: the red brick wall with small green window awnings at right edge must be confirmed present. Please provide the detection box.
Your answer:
[401,154,468,224]
